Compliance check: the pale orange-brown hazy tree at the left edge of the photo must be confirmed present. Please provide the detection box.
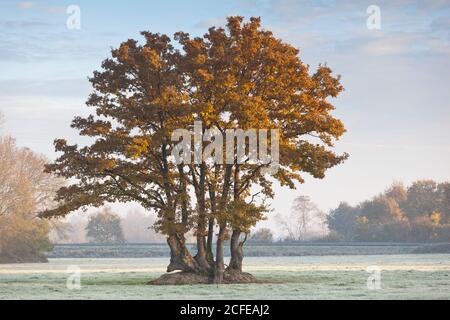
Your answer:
[0,137,62,263]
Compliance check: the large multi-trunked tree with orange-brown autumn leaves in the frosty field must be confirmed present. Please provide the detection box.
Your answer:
[42,17,347,283]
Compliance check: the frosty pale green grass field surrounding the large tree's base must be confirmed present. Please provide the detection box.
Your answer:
[0,254,450,299]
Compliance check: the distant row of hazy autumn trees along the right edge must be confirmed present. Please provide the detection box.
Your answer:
[327,180,450,242]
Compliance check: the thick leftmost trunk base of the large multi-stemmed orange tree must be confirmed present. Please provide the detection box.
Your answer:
[167,234,200,273]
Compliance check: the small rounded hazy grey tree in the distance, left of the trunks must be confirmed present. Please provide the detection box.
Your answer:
[86,208,125,244]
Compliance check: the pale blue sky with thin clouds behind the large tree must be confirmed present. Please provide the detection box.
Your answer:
[0,0,450,230]
